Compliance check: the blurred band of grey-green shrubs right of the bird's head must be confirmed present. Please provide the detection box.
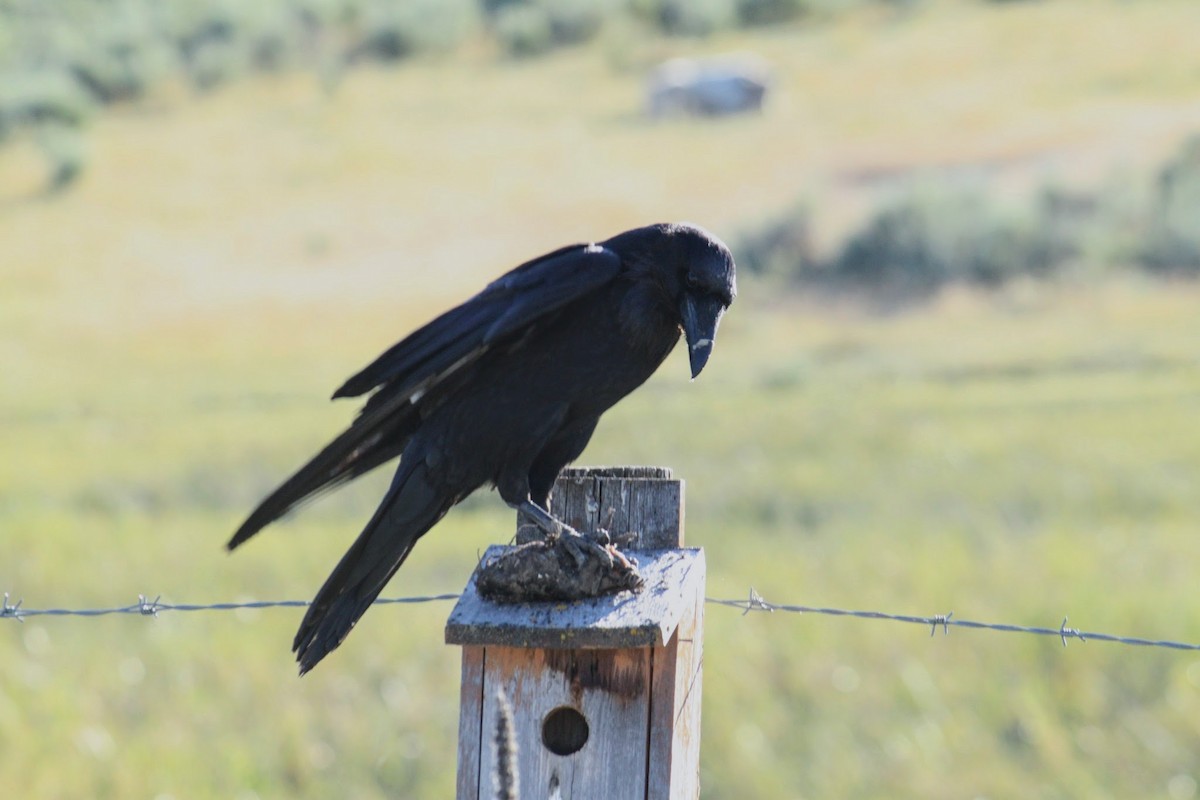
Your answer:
[738,134,1200,294]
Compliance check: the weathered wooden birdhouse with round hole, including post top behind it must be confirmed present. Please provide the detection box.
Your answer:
[445,467,704,800]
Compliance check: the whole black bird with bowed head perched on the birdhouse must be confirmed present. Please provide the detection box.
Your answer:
[228,224,737,674]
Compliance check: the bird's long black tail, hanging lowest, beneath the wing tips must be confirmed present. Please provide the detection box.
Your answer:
[292,457,458,675]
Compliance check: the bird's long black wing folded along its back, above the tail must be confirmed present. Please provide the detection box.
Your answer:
[228,245,620,549]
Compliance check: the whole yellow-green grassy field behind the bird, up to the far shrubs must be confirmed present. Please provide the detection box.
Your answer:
[0,0,1200,800]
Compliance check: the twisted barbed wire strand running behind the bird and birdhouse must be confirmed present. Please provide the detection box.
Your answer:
[0,587,1200,651]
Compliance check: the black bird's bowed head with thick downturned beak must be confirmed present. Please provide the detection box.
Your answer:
[671,223,738,378]
